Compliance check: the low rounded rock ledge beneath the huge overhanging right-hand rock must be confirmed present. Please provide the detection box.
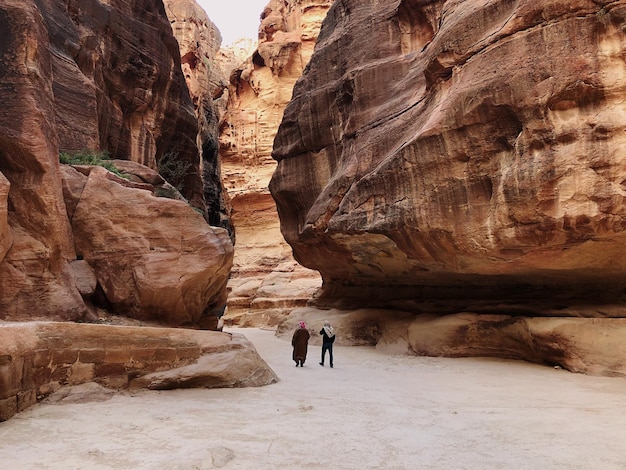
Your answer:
[277,307,626,377]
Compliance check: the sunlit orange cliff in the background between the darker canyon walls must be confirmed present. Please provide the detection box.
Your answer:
[220,0,332,324]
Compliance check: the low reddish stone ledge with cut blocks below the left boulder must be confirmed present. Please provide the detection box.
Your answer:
[0,322,278,421]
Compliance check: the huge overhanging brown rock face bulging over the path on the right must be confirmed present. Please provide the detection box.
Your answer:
[270,0,626,310]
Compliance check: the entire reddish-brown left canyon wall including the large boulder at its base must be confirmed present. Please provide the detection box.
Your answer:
[0,0,232,325]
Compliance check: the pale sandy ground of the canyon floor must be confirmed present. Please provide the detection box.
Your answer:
[0,329,626,470]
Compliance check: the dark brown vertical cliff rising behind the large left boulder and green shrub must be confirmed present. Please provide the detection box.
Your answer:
[37,0,204,209]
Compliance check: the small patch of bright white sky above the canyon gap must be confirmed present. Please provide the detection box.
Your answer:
[196,0,269,46]
